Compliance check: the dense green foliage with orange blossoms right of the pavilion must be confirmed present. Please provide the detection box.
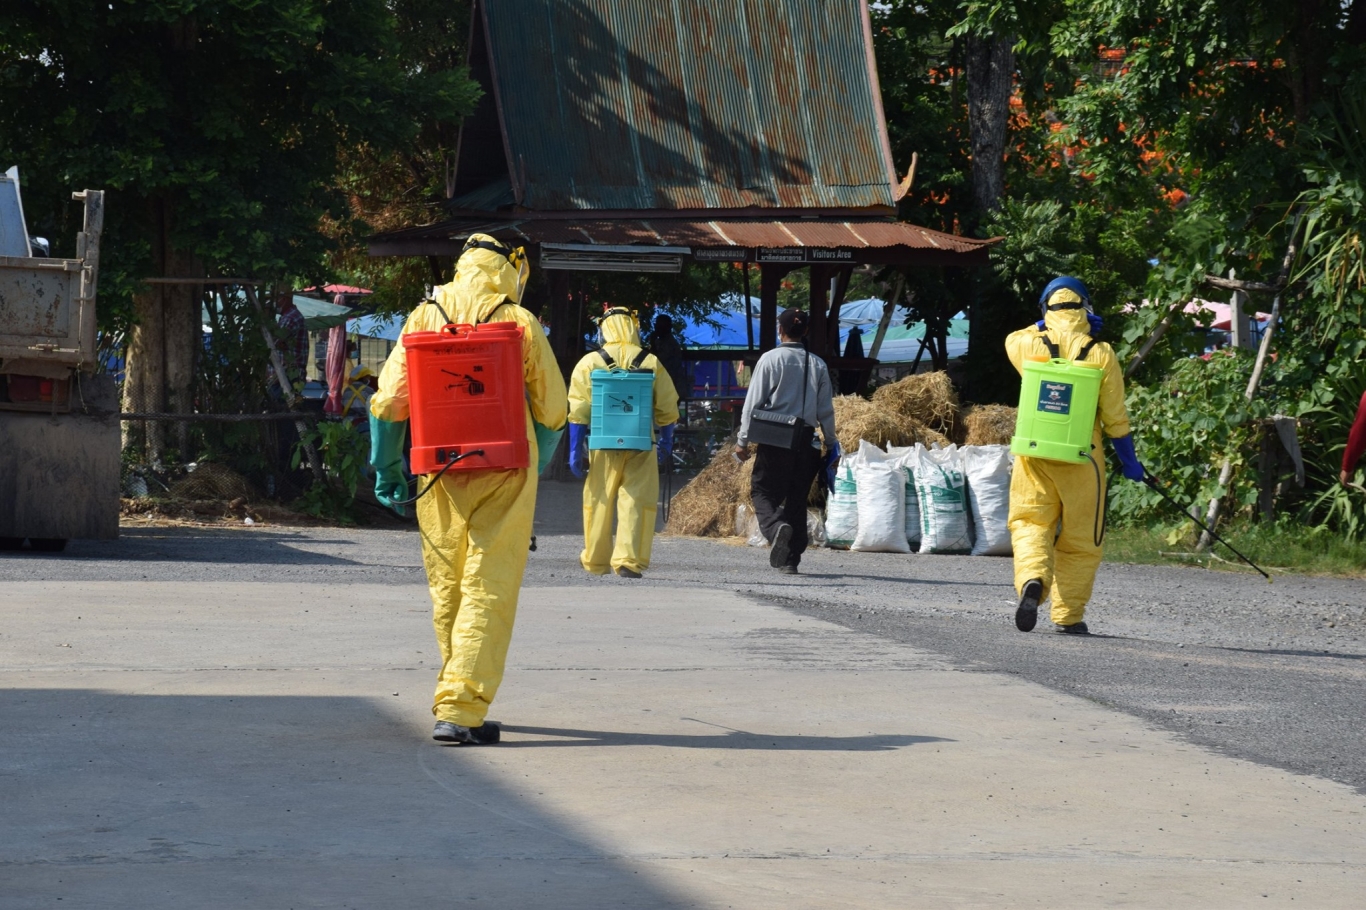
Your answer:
[874,0,1366,533]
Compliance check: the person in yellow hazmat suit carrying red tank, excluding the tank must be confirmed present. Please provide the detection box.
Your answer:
[370,234,567,745]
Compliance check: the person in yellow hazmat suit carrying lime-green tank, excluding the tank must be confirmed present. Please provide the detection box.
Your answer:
[1005,276,1143,634]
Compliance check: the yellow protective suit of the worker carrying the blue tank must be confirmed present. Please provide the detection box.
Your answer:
[570,313,679,575]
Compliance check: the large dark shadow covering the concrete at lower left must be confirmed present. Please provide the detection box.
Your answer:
[0,683,697,910]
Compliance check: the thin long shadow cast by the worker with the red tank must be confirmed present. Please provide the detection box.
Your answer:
[503,717,953,752]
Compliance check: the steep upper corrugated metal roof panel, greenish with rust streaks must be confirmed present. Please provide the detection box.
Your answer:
[481,0,896,210]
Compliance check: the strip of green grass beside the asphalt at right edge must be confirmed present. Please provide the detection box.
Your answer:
[1105,522,1366,578]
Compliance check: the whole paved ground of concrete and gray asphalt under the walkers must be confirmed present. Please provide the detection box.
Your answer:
[0,485,1366,910]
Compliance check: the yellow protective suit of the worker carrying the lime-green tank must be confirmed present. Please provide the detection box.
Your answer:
[1005,290,1130,626]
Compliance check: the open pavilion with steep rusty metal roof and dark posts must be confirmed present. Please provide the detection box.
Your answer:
[369,0,990,359]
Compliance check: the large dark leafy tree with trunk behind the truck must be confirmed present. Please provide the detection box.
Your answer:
[0,0,477,456]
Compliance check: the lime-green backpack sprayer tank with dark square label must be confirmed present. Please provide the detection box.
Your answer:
[1011,339,1105,465]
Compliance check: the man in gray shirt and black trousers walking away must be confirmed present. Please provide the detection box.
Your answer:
[735,309,839,575]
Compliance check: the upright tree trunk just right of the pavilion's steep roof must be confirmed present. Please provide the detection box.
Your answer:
[966,36,1015,216]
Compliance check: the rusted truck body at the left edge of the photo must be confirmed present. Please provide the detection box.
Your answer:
[0,190,119,551]
